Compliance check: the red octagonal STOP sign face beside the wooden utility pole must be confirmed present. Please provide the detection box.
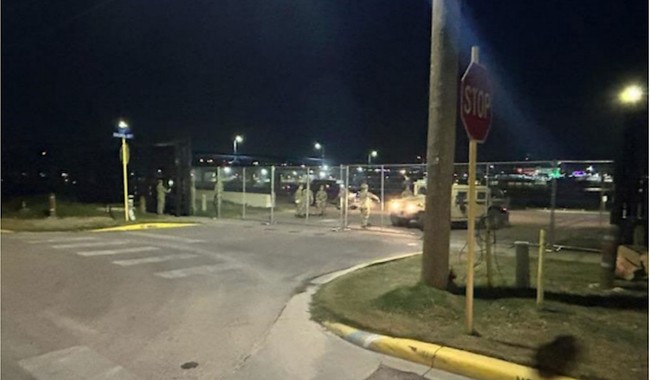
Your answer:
[460,62,492,142]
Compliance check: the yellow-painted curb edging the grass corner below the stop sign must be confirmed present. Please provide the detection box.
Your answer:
[323,322,573,380]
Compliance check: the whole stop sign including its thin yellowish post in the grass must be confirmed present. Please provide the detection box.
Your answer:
[460,46,492,334]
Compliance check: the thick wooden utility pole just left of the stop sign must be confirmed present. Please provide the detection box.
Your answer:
[421,0,460,289]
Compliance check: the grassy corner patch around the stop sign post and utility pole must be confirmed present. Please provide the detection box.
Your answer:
[311,256,648,379]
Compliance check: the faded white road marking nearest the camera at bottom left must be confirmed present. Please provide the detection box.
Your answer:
[18,346,137,380]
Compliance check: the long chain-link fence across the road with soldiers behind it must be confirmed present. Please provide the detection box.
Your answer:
[193,161,614,252]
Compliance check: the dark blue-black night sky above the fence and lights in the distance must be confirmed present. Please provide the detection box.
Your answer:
[1,0,648,163]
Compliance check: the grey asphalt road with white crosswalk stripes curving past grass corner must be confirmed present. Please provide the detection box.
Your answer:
[1,221,468,380]
